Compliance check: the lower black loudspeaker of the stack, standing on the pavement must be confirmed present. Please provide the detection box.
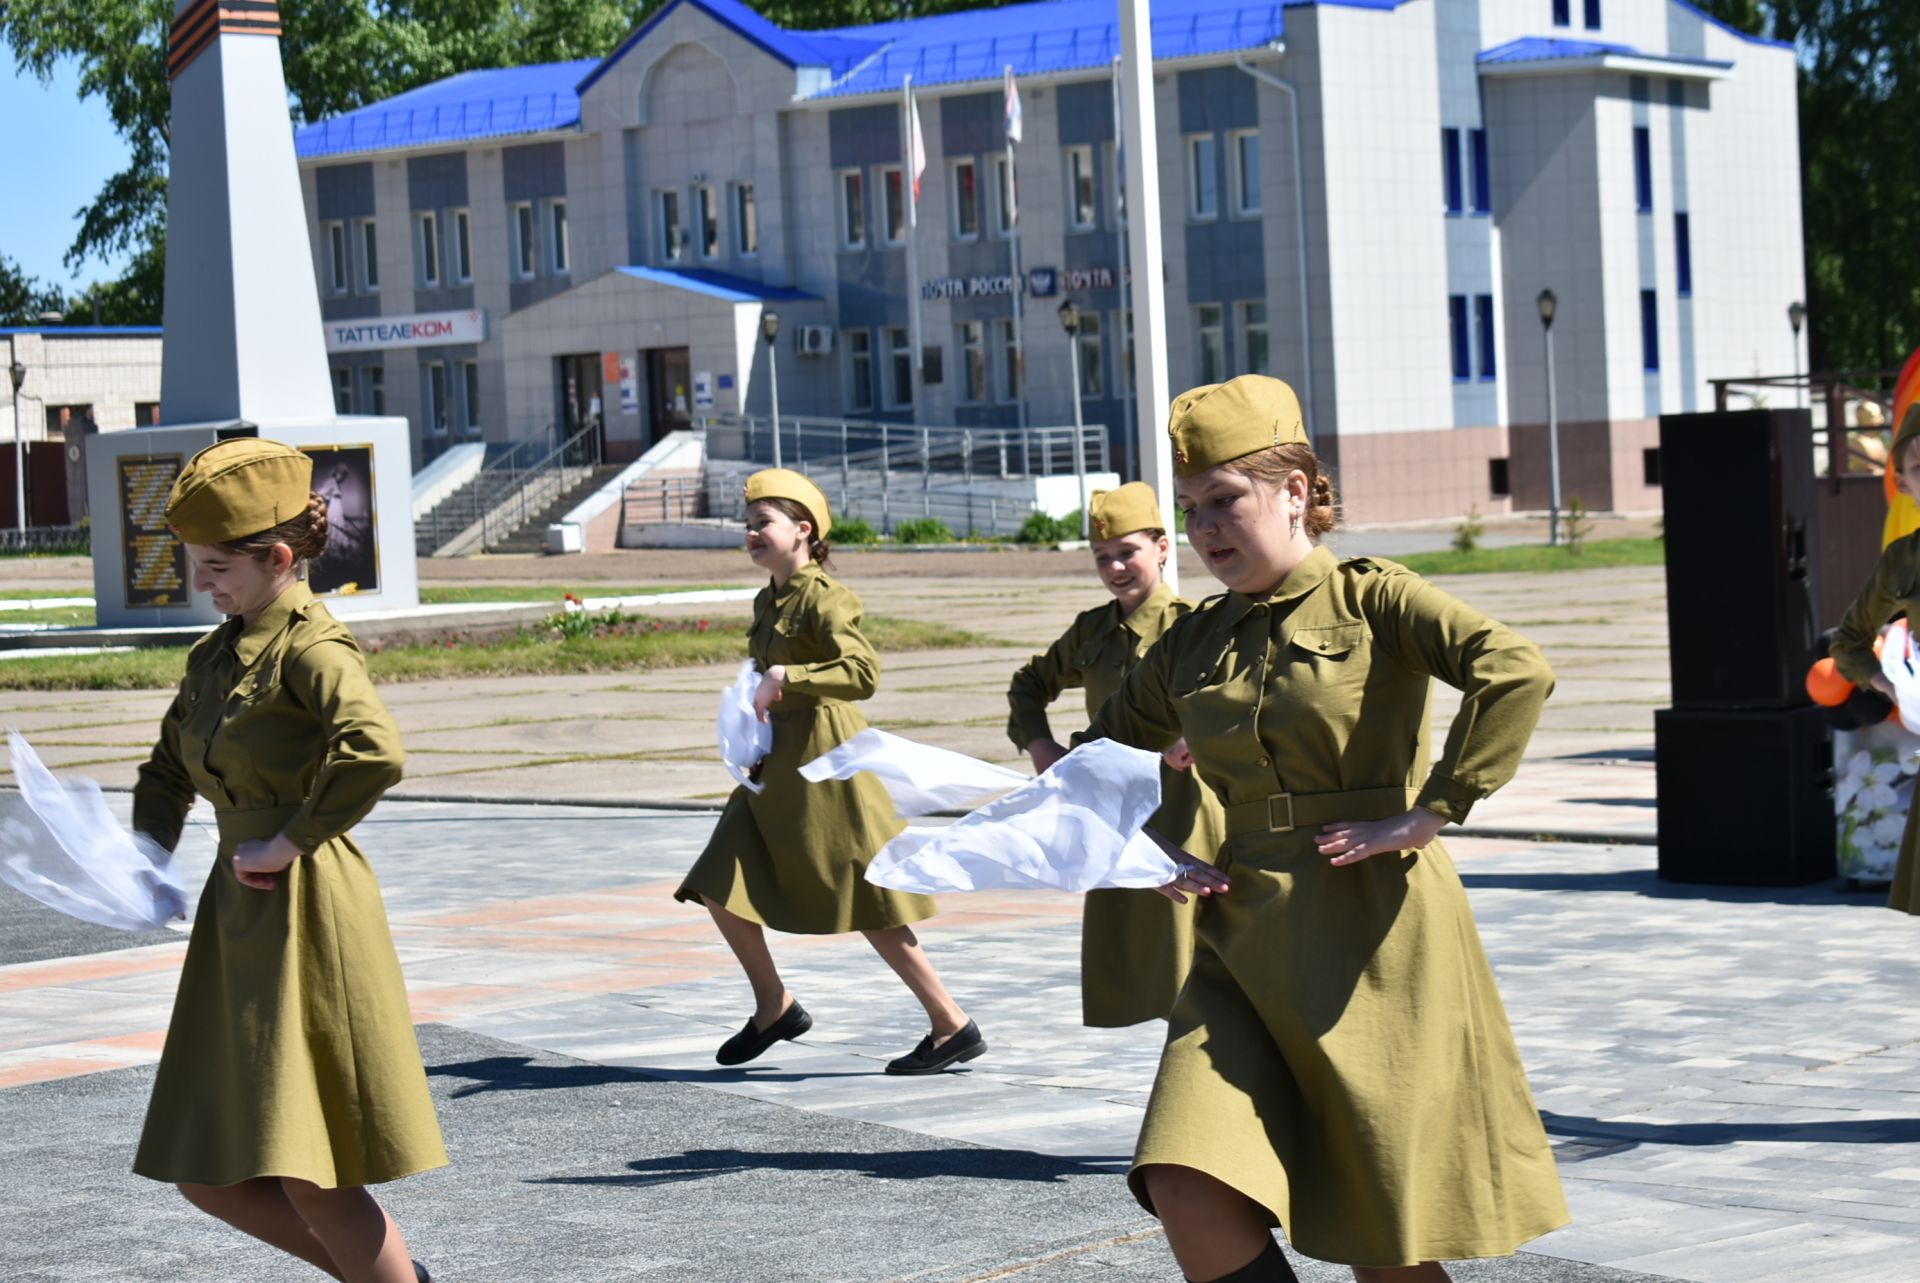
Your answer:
[1653,707,1836,887]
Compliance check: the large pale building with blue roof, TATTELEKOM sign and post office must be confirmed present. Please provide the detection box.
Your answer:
[298,0,1803,520]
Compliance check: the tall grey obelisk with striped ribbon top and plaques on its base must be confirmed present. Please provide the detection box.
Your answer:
[86,0,420,628]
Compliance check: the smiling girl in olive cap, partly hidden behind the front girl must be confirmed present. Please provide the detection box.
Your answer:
[1006,482,1225,1028]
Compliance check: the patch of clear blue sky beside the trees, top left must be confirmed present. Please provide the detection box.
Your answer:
[0,58,127,290]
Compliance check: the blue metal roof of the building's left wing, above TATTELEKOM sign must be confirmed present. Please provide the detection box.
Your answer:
[294,58,597,159]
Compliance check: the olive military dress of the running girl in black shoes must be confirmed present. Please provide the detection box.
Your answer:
[674,563,935,935]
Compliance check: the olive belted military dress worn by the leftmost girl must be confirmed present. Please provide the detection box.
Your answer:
[132,584,447,1187]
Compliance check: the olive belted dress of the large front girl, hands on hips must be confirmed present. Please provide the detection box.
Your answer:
[1087,547,1567,1268]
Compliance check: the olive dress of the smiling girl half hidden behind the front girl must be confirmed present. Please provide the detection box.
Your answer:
[1006,584,1227,1028]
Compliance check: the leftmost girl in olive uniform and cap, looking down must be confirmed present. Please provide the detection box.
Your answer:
[132,440,447,1283]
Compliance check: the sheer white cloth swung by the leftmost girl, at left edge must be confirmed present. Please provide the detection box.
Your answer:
[0,732,186,932]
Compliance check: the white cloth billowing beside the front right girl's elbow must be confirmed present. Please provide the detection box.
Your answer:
[801,730,1179,895]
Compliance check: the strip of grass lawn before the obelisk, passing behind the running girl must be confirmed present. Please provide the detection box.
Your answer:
[0,617,1000,691]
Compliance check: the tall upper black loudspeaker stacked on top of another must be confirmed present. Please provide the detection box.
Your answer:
[1661,409,1832,709]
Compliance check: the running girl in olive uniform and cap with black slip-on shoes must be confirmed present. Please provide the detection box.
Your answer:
[676,469,987,1074]
